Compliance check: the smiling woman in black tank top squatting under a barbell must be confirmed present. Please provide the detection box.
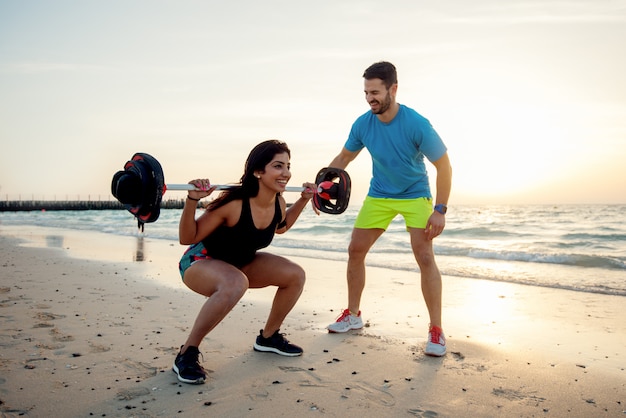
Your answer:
[173,140,316,384]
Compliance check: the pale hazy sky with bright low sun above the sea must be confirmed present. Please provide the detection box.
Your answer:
[0,0,626,206]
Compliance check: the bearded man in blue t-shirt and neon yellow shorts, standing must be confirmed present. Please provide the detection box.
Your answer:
[328,62,452,357]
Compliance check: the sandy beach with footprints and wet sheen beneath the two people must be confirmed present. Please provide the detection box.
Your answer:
[0,225,626,417]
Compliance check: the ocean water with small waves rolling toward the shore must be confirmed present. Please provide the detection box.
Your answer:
[0,205,626,296]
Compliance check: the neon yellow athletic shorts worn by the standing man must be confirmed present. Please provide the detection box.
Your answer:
[354,196,433,230]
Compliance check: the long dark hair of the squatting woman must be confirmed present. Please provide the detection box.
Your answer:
[207,139,291,209]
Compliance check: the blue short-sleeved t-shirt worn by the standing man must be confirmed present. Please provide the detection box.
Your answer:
[344,105,447,199]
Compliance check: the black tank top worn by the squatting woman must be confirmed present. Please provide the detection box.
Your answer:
[202,198,282,268]
